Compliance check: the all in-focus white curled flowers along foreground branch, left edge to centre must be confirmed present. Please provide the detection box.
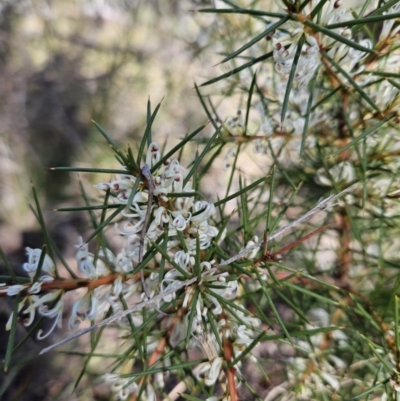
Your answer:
[0,142,260,400]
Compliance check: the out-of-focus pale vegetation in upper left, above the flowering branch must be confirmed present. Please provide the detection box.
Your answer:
[0,0,217,229]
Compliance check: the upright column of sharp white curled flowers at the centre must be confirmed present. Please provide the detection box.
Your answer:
[90,142,260,399]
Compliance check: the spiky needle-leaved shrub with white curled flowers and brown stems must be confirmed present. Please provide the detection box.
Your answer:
[0,0,400,401]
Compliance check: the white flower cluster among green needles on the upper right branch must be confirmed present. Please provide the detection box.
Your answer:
[217,0,400,174]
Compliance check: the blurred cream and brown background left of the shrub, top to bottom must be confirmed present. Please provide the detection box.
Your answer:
[0,0,223,401]
